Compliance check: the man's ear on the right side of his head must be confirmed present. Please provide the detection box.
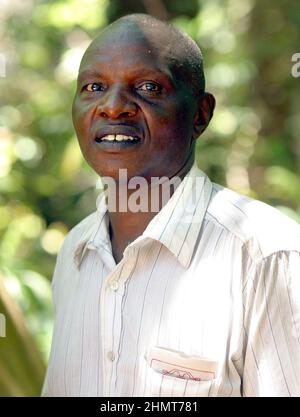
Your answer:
[193,93,216,139]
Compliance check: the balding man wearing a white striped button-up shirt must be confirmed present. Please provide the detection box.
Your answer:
[43,15,300,397]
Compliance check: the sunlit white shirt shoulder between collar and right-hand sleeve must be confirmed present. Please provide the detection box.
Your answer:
[207,184,300,260]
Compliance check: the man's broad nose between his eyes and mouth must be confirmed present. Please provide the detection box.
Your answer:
[98,85,137,119]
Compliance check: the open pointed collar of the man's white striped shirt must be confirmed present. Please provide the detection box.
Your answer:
[74,162,212,268]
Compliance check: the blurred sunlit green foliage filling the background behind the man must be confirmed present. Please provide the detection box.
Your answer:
[0,0,300,395]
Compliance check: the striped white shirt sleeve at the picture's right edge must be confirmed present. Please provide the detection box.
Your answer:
[242,251,300,397]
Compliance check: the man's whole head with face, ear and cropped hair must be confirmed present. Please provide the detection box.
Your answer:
[73,14,215,180]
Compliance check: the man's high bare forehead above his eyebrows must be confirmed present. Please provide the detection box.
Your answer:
[79,24,178,77]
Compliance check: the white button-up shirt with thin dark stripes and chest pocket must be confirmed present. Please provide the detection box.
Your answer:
[42,164,300,397]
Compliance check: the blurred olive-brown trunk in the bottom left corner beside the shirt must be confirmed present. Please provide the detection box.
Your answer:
[0,274,45,396]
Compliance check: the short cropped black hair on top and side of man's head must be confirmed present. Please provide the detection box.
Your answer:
[109,13,205,97]
